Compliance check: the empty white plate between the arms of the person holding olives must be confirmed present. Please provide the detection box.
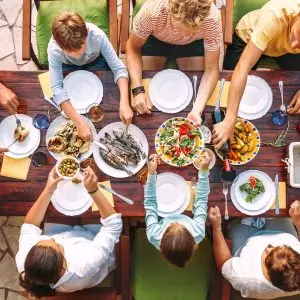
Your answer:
[51,176,93,216]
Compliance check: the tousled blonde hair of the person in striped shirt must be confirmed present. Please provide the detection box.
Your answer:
[169,0,212,28]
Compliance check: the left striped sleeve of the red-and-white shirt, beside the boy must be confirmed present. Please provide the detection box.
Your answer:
[132,1,157,39]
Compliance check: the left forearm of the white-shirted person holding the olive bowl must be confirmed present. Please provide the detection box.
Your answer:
[24,187,52,227]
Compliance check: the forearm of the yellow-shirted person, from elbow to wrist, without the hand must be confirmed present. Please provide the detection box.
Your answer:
[225,63,248,123]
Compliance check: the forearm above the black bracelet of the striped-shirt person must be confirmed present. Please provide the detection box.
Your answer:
[126,42,143,88]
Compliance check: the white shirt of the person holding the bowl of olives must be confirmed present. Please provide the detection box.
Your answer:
[16,214,122,292]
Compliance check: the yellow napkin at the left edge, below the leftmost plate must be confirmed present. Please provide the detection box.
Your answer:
[0,155,31,180]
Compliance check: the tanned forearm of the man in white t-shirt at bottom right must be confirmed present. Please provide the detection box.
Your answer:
[213,227,232,270]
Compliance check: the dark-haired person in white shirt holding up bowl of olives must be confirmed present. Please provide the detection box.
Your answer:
[16,168,122,297]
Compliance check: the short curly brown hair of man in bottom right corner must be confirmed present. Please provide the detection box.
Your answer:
[265,245,300,292]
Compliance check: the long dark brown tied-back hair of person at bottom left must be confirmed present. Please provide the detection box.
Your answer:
[19,244,64,298]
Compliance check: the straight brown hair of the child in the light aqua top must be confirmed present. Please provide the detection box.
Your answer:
[160,223,196,268]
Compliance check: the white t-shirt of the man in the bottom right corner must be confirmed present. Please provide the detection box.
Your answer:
[222,233,300,299]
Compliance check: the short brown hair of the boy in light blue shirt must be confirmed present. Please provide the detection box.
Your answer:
[52,11,88,51]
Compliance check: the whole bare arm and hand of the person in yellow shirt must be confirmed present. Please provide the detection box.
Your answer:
[213,41,263,149]
